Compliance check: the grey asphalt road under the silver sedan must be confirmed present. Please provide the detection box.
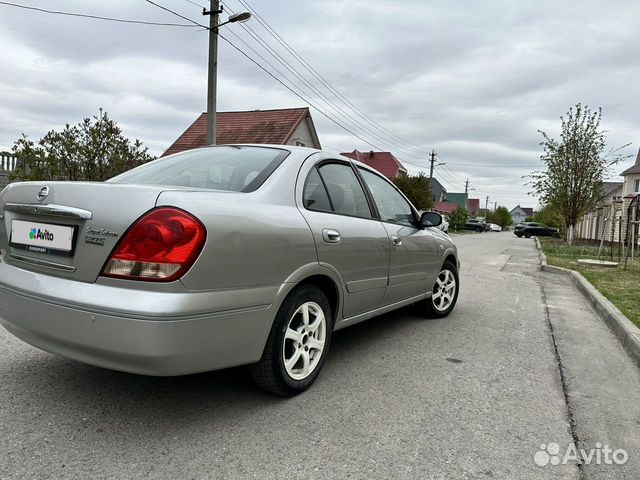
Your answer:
[0,232,640,479]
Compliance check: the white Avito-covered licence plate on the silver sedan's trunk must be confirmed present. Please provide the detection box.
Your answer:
[9,220,78,257]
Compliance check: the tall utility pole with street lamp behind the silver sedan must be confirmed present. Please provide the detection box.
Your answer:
[202,0,251,145]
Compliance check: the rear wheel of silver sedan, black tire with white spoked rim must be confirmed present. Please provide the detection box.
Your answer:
[249,285,333,397]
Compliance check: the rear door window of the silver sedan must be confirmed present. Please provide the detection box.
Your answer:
[318,163,371,218]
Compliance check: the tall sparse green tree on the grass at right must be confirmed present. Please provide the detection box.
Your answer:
[530,103,626,243]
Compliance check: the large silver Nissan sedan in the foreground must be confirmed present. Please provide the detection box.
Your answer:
[0,145,460,396]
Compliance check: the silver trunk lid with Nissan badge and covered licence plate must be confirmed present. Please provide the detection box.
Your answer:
[0,182,167,282]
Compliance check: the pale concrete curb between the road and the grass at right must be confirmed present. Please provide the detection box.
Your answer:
[536,238,640,367]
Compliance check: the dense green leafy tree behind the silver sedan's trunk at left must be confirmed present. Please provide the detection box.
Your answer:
[10,109,153,181]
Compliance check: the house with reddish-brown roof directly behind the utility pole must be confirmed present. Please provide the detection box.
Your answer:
[162,107,321,157]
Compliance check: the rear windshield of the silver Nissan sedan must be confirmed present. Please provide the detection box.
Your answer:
[108,146,289,192]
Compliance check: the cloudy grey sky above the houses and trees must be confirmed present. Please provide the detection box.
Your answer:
[0,0,640,208]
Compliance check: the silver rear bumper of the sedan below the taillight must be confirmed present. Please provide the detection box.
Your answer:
[0,263,275,375]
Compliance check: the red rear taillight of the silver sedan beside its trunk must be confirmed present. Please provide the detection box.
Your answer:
[101,207,206,282]
